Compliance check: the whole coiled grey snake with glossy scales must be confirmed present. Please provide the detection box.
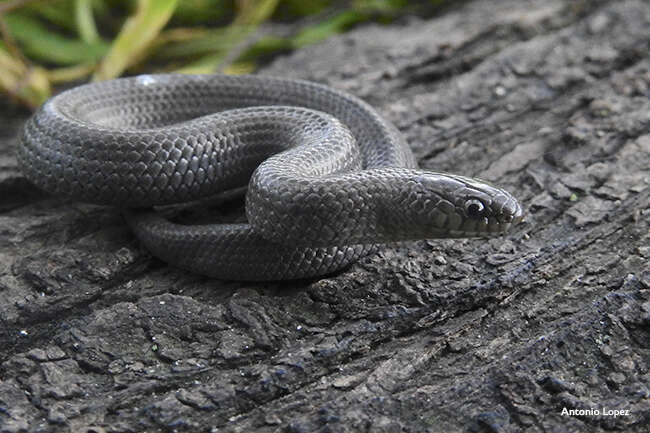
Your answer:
[17,73,523,281]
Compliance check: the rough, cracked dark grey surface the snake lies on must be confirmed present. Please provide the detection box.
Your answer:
[0,0,650,433]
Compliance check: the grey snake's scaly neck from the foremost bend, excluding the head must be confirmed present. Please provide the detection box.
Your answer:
[246,167,440,246]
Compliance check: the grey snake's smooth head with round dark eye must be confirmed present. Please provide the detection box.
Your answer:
[400,172,523,238]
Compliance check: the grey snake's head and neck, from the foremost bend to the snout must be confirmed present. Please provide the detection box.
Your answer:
[246,165,522,246]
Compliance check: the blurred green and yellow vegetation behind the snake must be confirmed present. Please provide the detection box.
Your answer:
[0,0,446,108]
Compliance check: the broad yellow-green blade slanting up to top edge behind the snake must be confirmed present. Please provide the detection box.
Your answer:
[94,0,177,80]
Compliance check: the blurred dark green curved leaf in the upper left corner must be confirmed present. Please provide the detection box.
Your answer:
[5,12,108,65]
